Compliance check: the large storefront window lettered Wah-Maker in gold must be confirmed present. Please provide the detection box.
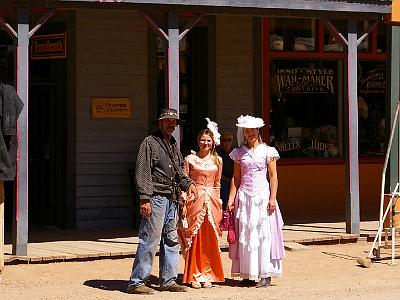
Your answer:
[270,59,341,158]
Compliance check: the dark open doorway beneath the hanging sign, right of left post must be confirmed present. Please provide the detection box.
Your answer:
[28,24,68,229]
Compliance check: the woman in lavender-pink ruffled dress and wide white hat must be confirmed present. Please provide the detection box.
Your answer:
[228,116,285,287]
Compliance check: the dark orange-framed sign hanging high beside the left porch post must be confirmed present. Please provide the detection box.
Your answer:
[31,33,67,59]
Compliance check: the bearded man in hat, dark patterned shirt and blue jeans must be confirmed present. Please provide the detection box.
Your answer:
[127,108,197,294]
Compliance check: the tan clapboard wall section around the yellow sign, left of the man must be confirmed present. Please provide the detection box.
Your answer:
[76,10,148,228]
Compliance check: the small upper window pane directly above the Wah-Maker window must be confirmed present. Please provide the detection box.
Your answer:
[270,18,315,51]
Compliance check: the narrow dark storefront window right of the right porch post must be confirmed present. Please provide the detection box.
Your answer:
[358,61,386,156]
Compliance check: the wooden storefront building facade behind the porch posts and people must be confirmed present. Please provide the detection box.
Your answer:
[0,0,398,255]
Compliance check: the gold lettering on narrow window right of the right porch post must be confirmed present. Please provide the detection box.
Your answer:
[358,62,386,96]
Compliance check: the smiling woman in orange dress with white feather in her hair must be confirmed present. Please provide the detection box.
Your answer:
[178,119,225,288]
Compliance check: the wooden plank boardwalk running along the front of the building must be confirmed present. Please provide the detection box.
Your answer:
[4,221,378,265]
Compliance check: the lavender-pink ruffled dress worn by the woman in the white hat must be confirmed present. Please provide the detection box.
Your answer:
[229,144,285,280]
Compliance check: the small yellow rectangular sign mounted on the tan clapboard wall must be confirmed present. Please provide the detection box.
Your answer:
[92,97,132,118]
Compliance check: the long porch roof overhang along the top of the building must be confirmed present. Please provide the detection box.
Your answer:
[1,0,392,18]
